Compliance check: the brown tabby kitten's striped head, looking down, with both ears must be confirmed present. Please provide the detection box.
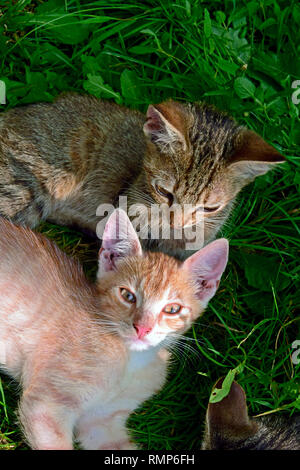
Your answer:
[141,100,284,242]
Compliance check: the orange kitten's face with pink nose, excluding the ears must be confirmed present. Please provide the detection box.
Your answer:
[98,253,200,350]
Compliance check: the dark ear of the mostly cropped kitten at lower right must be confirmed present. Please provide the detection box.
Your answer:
[206,378,256,443]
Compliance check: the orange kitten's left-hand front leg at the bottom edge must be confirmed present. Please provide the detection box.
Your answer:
[19,395,75,450]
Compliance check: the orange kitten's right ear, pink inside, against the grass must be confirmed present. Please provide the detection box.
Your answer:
[182,238,229,306]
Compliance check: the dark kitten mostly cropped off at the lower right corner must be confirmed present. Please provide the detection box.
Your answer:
[202,379,300,450]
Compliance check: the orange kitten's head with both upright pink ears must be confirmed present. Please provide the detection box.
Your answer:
[98,209,228,350]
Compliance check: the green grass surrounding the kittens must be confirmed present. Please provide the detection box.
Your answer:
[0,0,300,450]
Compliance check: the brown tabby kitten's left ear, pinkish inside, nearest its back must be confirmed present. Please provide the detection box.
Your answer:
[144,100,187,152]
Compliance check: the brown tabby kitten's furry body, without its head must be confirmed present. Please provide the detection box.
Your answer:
[0,93,145,229]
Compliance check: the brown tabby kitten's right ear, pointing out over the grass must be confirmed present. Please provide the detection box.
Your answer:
[229,130,285,184]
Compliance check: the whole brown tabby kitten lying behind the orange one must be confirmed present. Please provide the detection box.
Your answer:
[0,93,284,255]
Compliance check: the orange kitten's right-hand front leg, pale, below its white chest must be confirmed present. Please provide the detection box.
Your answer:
[76,411,137,450]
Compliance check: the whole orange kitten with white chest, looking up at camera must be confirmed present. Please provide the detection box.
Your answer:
[0,210,228,449]
